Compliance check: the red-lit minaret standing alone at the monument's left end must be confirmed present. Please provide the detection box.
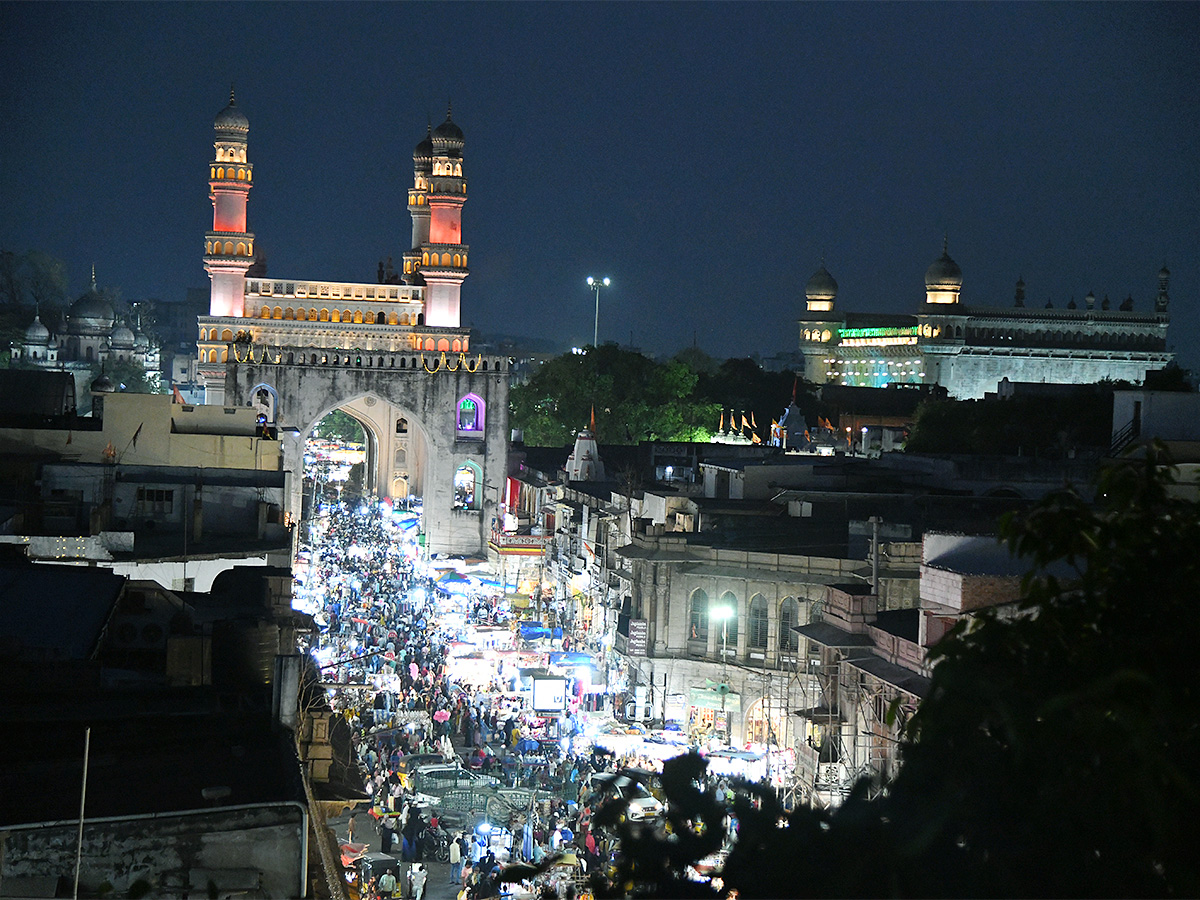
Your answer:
[204,88,254,317]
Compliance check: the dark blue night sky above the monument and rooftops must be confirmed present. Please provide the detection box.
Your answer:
[0,2,1200,368]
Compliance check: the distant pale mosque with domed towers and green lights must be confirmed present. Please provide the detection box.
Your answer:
[799,246,1175,400]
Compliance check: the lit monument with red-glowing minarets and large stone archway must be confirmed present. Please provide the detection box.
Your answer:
[197,91,509,556]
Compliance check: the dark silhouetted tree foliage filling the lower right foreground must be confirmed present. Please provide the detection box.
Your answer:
[594,451,1200,898]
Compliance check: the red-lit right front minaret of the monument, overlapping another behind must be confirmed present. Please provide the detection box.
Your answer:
[410,108,467,328]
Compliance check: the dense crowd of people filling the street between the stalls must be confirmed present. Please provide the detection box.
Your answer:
[298,505,628,900]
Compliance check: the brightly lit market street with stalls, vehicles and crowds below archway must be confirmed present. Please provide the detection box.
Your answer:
[293,499,772,900]
